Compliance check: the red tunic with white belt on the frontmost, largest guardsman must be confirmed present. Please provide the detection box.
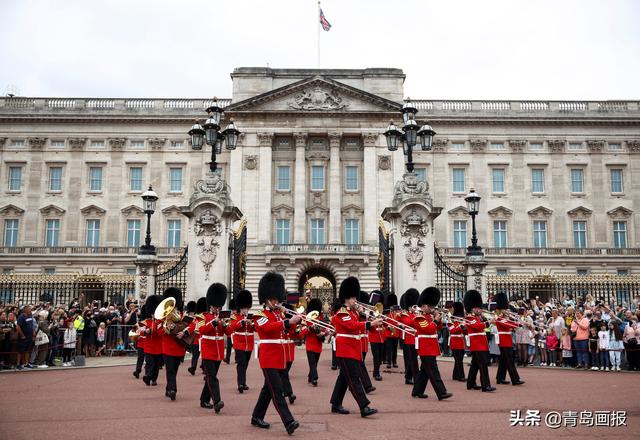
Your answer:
[253,309,287,370]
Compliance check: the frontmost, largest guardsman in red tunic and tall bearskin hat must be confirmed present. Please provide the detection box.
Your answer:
[251,272,300,435]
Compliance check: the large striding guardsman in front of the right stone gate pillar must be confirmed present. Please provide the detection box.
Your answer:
[411,287,453,400]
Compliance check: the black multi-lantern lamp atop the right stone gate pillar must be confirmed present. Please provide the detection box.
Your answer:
[384,100,436,173]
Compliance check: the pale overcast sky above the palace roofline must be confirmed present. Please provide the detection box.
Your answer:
[0,0,640,100]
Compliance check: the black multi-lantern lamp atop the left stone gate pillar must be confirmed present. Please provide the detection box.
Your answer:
[189,100,240,173]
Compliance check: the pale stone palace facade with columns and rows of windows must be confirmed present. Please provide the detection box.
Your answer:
[0,68,640,296]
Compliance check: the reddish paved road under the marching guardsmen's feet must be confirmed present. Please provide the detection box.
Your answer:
[0,349,640,440]
